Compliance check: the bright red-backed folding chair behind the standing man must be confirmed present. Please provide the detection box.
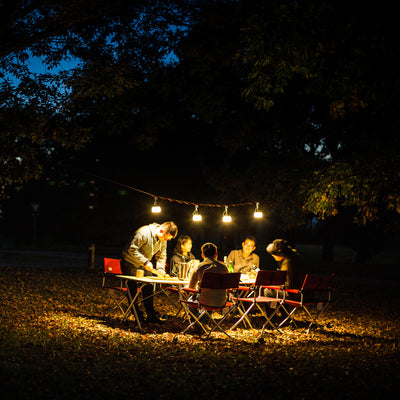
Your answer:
[102,258,128,316]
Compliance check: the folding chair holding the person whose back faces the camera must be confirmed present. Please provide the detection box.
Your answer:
[181,272,240,339]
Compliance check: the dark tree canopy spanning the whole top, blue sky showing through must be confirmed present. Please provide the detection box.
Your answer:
[0,0,400,236]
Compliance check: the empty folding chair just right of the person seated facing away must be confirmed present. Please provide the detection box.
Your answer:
[231,270,286,335]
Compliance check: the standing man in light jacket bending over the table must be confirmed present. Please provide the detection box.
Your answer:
[121,221,178,323]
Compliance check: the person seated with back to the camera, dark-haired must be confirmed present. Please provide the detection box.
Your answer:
[189,243,228,307]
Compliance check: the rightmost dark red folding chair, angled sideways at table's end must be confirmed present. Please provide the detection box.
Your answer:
[279,274,334,334]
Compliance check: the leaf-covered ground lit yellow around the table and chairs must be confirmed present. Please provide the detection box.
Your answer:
[0,255,400,400]
